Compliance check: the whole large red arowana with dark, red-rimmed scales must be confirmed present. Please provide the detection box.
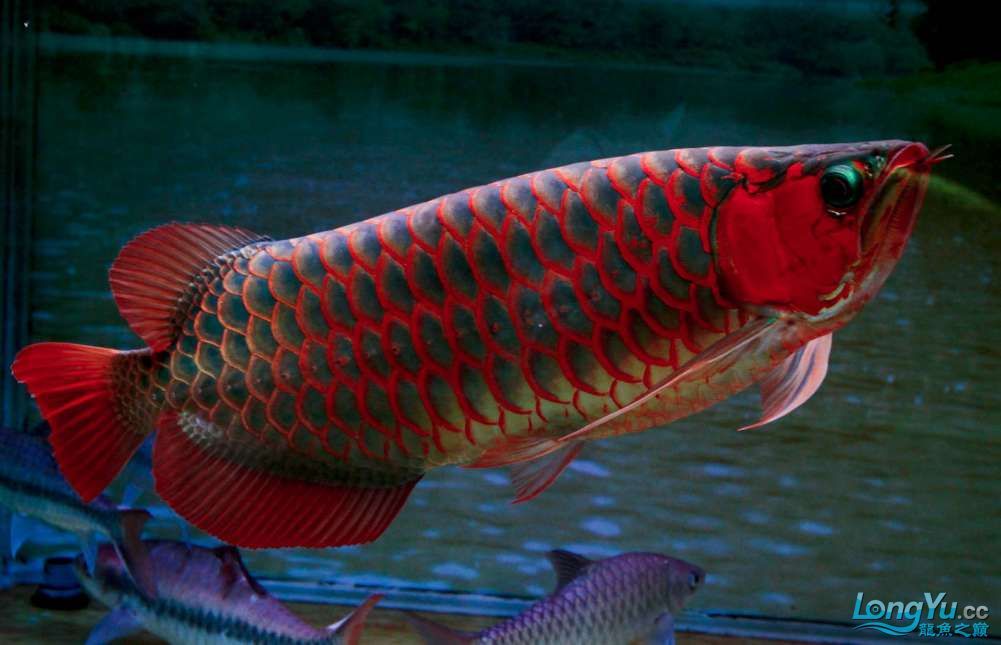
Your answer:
[13,141,944,547]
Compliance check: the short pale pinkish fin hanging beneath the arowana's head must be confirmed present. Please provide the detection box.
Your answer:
[740,334,833,431]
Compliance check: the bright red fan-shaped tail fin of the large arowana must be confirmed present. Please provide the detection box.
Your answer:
[11,343,150,502]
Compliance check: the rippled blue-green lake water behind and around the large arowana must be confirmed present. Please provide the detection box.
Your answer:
[17,37,1001,620]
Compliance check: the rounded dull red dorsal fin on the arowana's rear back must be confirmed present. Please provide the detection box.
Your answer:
[109,222,269,352]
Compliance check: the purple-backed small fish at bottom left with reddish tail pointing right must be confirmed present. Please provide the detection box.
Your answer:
[76,540,381,645]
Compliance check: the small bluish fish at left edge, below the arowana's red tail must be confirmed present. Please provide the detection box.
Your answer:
[0,428,152,593]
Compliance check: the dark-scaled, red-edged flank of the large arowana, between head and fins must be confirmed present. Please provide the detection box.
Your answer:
[158,148,746,471]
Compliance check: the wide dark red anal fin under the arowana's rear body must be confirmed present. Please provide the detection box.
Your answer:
[153,414,420,549]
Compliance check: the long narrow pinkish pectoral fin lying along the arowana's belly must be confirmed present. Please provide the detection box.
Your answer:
[557,318,776,443]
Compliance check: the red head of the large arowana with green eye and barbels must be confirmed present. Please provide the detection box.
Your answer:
[714,141,946,331]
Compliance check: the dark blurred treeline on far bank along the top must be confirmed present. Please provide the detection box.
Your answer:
[40,0,964,76]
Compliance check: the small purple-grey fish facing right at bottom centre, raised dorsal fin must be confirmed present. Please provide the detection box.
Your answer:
[407,550,706,645]
